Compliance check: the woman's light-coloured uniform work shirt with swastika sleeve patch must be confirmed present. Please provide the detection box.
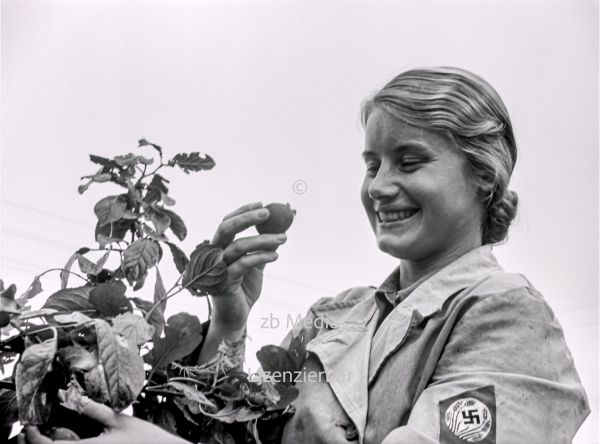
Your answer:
[270,245,589,444]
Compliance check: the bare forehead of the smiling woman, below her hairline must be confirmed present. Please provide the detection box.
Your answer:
[365,108,451,150]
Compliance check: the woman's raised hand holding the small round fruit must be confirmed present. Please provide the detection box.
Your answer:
[211,202,287,330]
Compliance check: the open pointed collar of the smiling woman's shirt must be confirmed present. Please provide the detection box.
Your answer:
[375,245,502,314]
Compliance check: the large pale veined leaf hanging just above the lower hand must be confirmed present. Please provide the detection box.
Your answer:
[94,319,145,411]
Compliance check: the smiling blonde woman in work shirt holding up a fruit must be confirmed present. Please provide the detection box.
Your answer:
[28,68,589,444]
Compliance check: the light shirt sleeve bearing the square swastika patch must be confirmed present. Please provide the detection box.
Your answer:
[382,287,590,444]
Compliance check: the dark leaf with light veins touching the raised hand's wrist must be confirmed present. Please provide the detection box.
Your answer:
[182,240,227,296]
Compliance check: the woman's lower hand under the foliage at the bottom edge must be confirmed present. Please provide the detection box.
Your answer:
[19,400,189,444]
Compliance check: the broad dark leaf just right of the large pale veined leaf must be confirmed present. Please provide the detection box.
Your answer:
[144,313,202,368]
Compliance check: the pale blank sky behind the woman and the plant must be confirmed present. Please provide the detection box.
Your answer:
[0,0,599,444]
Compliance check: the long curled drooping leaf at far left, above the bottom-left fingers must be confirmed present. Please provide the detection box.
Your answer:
[15,328,57,425]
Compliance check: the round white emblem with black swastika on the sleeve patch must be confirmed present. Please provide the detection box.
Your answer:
[444,398,492,442]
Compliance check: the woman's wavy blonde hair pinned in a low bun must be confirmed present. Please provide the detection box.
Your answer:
[361,67,518,244]
